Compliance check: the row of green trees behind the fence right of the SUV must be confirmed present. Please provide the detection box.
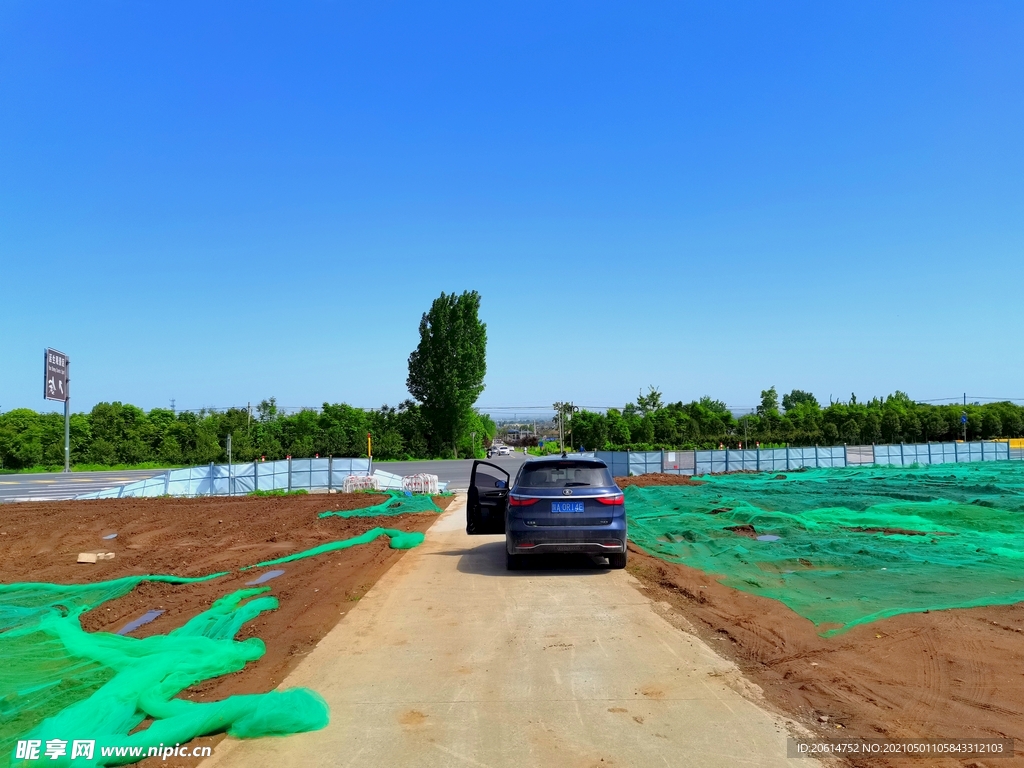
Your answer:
[567,387,1024,451]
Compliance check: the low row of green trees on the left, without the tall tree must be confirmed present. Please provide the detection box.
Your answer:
[0,397,495,469]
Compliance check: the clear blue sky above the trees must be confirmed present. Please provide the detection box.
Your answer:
[0,0,1024,421]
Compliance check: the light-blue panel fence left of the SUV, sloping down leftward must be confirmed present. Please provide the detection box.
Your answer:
[75,459,372,499]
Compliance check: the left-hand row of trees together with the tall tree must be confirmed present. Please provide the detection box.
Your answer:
[0,291,495,469]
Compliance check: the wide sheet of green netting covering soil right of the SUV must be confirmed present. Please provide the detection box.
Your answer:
[626,462,1024,635]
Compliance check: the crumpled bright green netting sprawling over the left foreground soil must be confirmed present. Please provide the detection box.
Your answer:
[0,528,423,766]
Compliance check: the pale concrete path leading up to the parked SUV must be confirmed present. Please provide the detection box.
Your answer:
[203,496,816,768]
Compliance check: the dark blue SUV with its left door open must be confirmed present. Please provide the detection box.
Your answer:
[466,456,626,570]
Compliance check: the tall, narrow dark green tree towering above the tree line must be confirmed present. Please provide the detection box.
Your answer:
[406,291,487,457]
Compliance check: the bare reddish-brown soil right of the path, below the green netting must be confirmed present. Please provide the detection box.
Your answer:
[630,545,1024,768]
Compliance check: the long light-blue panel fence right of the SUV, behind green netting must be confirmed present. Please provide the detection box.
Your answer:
[587,440,1024,477]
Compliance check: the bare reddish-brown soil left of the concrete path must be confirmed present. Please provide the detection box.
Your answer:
[0,494,453,768]
